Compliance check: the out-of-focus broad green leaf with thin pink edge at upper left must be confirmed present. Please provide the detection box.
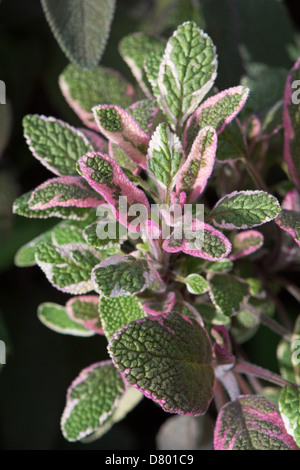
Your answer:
[59,64,135,130]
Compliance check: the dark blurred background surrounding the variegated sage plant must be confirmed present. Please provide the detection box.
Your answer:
[0,0,300,450]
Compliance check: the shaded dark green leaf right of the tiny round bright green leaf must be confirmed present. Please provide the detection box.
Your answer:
[208,274,250,316]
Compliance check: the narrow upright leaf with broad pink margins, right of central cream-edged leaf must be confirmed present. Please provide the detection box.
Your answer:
[176,126,217,202]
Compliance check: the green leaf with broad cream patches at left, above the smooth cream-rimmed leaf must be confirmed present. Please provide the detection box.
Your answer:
[35,243,101,295]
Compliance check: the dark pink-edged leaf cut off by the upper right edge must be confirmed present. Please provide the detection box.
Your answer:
[283,58,300,191]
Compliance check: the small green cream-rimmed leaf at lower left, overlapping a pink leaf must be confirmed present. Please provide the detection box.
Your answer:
[38,302,94,337]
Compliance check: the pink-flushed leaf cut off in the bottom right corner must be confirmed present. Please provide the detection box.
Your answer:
[214,395,299,450]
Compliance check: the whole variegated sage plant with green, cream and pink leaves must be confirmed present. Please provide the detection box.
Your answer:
[14,22,300,450]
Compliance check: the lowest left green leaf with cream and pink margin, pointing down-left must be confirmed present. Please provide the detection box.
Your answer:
[61,361,141,442]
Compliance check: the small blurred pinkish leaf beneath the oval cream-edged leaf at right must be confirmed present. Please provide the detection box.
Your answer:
[230,230,264,260]
